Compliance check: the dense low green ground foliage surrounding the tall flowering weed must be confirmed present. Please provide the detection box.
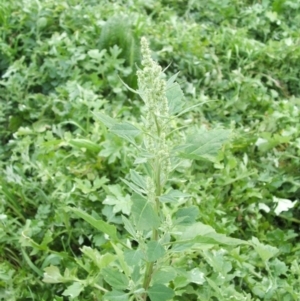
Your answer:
[0,0,300,301]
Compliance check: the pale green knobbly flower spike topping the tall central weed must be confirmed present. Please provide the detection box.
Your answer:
[137,37,171,185]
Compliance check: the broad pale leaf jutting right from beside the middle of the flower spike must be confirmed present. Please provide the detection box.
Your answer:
[177,130,230,161]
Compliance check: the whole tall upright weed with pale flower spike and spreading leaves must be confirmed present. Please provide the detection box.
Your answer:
[43,38,277,301]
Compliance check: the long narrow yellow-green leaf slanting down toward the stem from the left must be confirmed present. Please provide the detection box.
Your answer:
[66,207,118,240]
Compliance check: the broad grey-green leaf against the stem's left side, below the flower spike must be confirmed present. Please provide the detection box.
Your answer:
[131,194,160,231]
